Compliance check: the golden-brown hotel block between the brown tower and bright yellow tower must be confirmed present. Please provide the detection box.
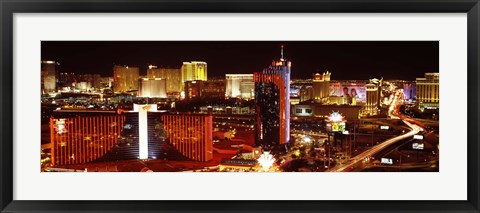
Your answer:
[147,65,182,95]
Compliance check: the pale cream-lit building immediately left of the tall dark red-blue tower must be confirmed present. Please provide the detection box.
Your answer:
[225,74,255,99]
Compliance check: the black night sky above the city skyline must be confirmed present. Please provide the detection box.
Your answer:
[41,41,439,80]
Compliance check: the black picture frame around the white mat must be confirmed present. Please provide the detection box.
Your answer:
[0,0,480,212]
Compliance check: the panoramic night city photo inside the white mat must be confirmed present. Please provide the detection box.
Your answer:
[40,41,440,172]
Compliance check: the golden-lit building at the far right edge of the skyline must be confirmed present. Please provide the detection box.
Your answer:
[416,72,440,109]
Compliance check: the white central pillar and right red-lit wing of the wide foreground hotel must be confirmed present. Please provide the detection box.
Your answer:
[127,104,213,161]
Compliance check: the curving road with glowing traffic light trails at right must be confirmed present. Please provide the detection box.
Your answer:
[327,89,422,172]
